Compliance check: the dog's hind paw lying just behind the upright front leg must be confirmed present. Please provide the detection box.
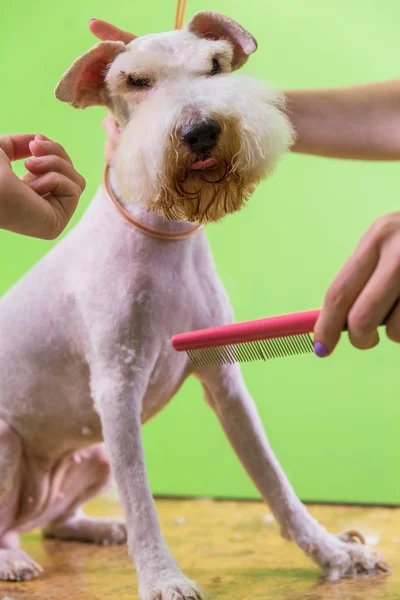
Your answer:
[43,516,127,546]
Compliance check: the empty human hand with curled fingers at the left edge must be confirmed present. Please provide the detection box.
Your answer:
[0,134,86,240]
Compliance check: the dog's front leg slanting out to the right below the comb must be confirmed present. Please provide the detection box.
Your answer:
[197,365,388,581]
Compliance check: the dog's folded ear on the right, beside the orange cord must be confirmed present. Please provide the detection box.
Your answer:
[185,10,257,70]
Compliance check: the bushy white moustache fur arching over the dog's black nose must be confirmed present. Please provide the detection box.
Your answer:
[115,72,292,206]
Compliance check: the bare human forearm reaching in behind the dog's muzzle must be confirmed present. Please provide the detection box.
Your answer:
[285,79,400,160]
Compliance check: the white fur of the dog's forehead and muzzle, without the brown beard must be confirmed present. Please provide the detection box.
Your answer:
[106,31,293,216]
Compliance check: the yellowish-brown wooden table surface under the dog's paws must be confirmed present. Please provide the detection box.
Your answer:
[0,495,400,600]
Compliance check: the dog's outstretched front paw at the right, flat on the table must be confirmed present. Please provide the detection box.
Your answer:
[310,531,390,582]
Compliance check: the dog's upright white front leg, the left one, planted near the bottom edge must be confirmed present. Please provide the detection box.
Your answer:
[92,369,199,600]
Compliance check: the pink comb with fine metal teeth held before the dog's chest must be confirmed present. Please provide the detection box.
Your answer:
[171,299,400,367]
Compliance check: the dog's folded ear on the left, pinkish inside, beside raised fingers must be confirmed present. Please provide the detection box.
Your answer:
[55,41,126,108]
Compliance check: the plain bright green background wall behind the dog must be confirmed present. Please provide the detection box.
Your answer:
[0,0,400,503]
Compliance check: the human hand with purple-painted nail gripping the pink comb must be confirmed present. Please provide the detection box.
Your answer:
[314,211,400,357]
